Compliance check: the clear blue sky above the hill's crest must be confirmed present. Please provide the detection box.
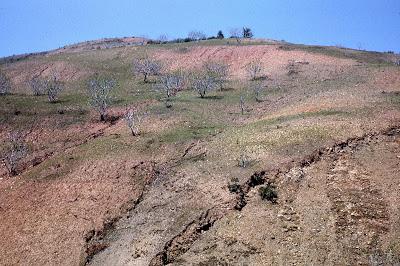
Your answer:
[0,0,400,56]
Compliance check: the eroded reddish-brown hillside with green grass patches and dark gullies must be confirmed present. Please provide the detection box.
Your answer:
[0,39,400,265]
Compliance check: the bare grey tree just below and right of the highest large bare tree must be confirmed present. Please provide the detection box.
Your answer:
[157,71,185,108]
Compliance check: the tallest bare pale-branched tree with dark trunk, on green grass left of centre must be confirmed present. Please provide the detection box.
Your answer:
[88,74,117,121]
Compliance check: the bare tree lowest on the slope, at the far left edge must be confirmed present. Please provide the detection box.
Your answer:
[2,131,28,176]
